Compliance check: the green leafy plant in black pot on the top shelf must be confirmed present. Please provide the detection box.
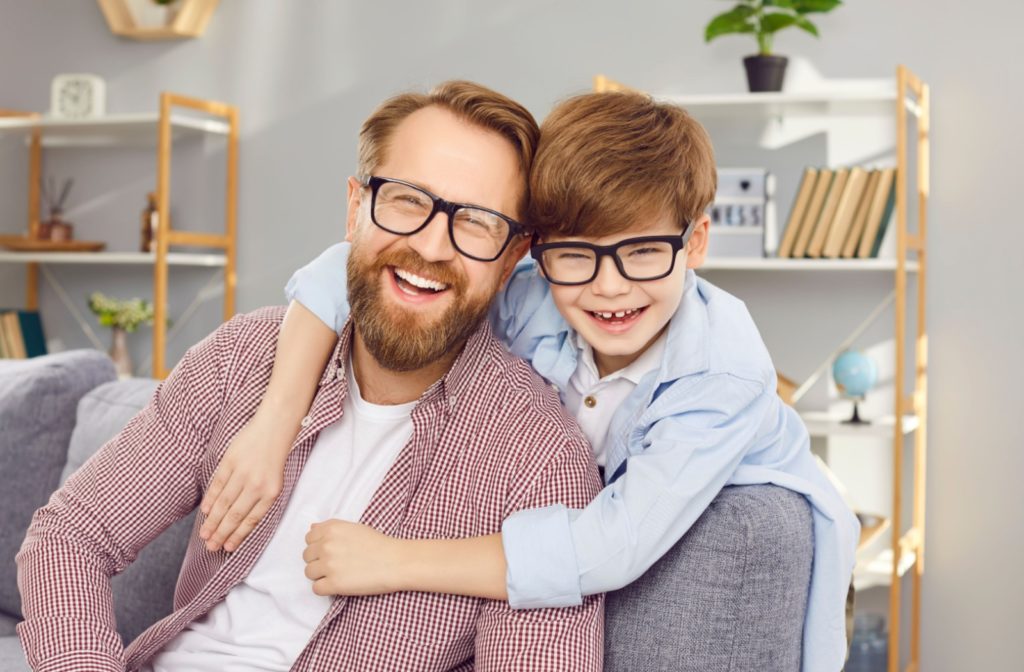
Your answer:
[705,0,843,91]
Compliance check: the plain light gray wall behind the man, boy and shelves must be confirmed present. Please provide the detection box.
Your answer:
[0,0,1024,671]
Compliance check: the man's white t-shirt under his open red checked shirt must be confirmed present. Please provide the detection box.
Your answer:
[143,356,416,672]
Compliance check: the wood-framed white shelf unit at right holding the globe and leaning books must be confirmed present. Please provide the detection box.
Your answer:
[594,66,930,672]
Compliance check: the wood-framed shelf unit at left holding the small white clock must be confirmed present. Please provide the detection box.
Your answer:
[0,92,239,378]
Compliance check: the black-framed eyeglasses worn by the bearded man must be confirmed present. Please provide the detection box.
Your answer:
[361,175,525,261]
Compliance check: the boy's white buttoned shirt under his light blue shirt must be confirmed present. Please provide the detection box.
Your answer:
[563,334,666,467]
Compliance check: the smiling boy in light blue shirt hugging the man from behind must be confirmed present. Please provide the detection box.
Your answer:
[202,93,859,671]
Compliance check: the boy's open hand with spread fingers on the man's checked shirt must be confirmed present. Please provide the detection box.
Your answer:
[199,412,297,551]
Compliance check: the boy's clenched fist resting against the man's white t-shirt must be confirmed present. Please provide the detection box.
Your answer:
[302,520,399,595]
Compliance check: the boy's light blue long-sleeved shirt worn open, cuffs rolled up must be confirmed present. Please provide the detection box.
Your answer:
[286,243,860,672]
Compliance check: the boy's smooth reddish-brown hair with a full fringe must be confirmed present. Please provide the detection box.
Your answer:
[527,92,718,238]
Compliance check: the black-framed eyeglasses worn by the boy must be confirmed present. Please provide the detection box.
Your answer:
[529,228,693,285]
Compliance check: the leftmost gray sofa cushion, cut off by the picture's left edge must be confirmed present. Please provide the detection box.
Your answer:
[0,350,117,617]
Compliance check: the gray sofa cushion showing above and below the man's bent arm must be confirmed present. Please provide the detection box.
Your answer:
[60,378,196,644]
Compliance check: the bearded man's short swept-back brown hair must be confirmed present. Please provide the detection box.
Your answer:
[357,80,541,213]
